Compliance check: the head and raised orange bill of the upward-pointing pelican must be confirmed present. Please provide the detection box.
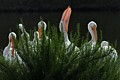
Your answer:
[59,6,72,32]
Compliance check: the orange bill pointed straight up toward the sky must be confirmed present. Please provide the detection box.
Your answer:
[61,6,72,32]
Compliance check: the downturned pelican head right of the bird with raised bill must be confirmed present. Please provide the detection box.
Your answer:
[88,21,97,44]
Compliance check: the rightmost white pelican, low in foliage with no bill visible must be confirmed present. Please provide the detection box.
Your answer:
[100,41,118,60]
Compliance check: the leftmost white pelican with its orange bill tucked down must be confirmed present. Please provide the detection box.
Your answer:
[3,32,22,63]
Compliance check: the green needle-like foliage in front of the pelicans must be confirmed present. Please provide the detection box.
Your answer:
[0,22,120,80]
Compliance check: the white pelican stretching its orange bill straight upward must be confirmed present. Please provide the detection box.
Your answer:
[59,6,79,52]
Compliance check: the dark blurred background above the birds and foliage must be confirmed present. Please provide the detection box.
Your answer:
[0,0,120,49]
